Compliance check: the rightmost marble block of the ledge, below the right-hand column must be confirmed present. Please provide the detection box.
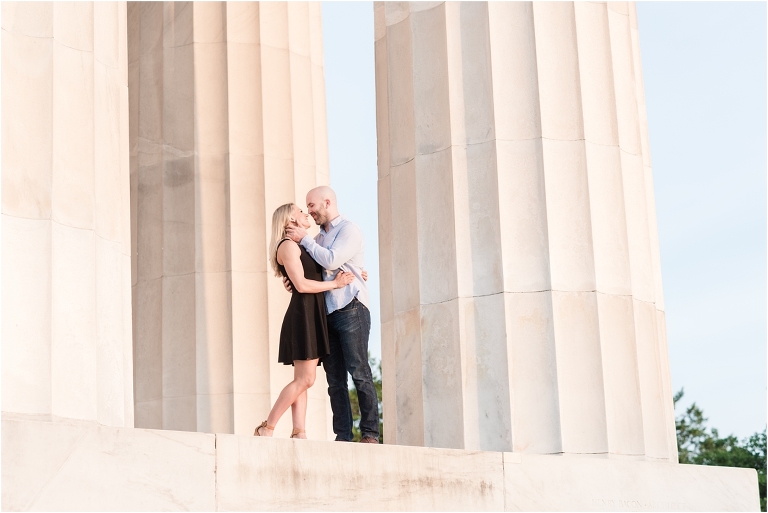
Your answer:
[504,453,760,511]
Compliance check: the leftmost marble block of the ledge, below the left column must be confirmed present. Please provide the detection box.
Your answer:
[2,413,215,511]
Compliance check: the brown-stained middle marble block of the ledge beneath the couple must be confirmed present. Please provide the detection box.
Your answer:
[216,435,504,511]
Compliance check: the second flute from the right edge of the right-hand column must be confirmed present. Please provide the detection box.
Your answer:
[574,3,645,456]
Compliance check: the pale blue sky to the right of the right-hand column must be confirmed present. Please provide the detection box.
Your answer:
[637,2,766,437]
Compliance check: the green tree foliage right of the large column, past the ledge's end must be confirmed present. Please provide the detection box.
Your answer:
[674,388,766,511]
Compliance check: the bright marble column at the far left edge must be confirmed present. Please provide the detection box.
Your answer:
[2,2,134,427]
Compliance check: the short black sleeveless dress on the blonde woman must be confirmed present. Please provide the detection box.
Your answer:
[277,239,331,365]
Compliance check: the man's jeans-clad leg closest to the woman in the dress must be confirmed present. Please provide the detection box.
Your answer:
[323,312,352,442]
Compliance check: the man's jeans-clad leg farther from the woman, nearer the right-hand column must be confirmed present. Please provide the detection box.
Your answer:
[337,300,379,440]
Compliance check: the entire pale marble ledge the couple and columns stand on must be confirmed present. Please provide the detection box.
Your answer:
[2,413,759,511]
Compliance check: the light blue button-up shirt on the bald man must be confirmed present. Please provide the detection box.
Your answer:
[301,216,371,314]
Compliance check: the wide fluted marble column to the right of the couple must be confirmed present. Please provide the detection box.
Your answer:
[374,2,677,461]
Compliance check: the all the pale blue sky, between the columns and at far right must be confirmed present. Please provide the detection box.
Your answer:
[323,2,767,437]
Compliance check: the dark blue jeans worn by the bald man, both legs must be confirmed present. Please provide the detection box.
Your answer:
[323,298,379,442]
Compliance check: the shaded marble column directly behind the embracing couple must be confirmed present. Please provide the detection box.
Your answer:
[128,2,330,439]
